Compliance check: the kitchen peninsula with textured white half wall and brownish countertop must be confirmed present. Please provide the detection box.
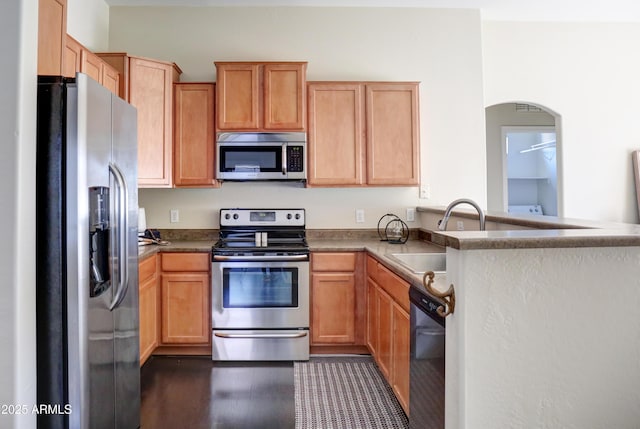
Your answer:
[418,208,640,429]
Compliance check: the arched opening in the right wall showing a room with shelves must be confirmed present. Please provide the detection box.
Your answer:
[485,102,562,216]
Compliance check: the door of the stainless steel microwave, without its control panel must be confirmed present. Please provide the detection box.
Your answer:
[216,143,287,180]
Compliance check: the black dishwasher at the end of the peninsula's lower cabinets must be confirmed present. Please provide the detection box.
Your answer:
[409,287,445,429]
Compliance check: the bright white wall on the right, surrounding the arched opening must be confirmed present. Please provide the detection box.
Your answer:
[482,21,640,223]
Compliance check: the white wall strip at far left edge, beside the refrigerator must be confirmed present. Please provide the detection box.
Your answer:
[0,0,38,428]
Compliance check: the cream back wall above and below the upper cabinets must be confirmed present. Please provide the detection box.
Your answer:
[109,7,486,228]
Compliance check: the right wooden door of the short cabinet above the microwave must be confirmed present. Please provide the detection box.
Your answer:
[263,63,306,131]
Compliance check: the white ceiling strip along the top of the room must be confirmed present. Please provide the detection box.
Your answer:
[105,0,640,22]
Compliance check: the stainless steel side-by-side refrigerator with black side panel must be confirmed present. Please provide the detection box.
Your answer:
[36,73,140,429]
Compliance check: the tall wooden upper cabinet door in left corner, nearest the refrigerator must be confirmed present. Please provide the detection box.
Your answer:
[129,58,173,187]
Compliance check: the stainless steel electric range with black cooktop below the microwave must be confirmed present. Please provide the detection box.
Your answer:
[211,209,309,361]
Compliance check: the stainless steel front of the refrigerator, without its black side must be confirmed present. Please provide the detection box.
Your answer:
[67,74,140,429]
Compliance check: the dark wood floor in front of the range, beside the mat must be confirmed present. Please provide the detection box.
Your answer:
[141,356,295,429]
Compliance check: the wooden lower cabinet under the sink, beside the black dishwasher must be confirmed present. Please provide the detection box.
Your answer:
[367,256,411,415]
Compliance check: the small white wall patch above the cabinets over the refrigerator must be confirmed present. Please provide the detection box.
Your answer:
[67,0,109,52]
